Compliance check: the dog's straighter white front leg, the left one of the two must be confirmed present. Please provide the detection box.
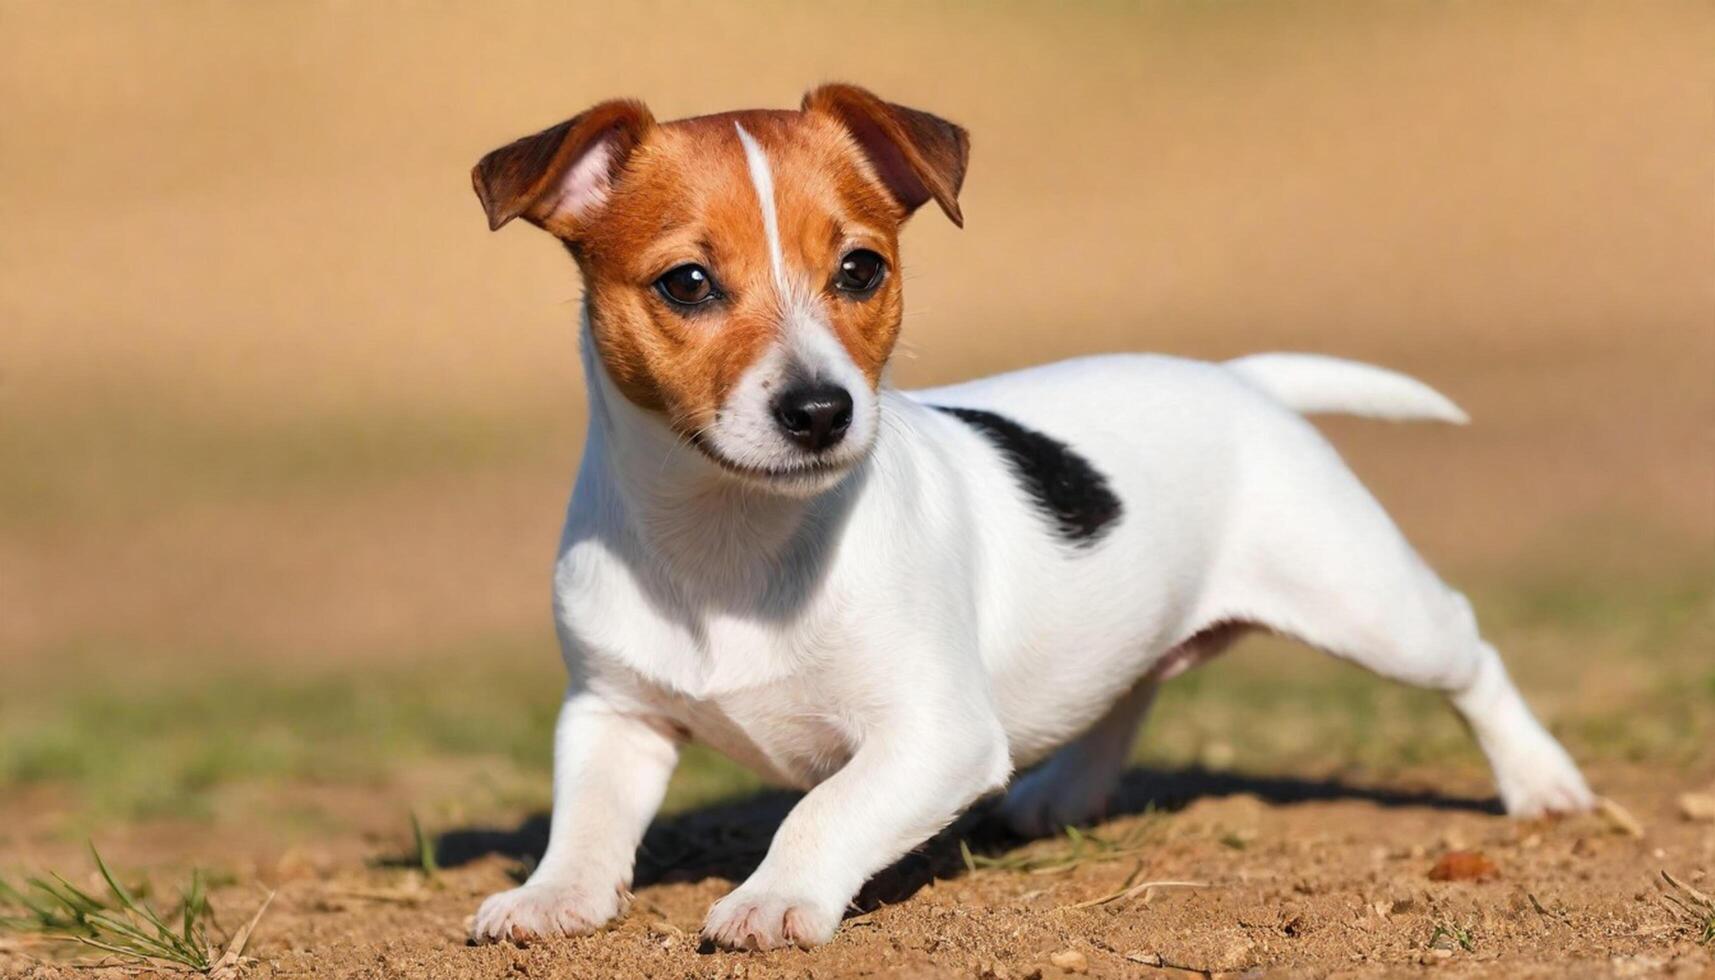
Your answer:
[470,690,679,942]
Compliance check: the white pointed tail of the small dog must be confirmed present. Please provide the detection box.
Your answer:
[1226,354,1471,426]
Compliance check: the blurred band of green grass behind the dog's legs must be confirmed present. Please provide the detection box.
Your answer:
[0,572,1715,832]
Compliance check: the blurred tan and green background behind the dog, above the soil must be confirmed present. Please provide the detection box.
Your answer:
[0,0,1715,860]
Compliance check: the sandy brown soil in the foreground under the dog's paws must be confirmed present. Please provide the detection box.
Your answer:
[0,769,1715,980]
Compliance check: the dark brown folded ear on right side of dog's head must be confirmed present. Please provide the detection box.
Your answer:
[803,84,971,228]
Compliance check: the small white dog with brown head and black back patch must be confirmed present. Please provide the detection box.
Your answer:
[470,84,1592,949]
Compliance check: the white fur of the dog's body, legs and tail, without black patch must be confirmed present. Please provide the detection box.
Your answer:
[473,338,1592,947]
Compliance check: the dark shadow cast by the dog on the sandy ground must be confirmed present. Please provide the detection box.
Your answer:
[436,767,1501,911]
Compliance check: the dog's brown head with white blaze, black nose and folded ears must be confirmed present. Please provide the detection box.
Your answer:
[472,84,969,491]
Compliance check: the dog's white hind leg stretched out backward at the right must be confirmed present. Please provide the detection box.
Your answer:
[1228,443,1593,817]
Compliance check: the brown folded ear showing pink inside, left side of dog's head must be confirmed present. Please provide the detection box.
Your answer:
[470,100,655,239]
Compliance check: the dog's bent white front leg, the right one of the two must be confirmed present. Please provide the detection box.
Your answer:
[703,705,1012,949]
